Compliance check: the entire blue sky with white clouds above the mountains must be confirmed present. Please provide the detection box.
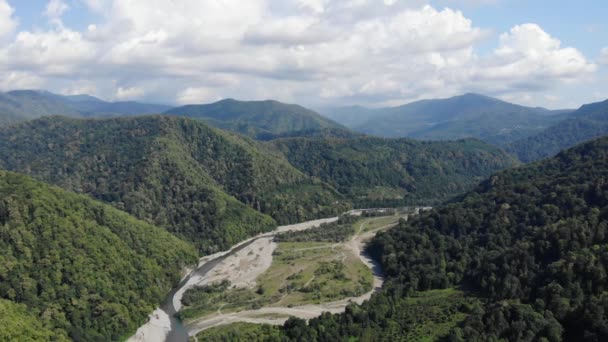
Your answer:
[0,0,608,108]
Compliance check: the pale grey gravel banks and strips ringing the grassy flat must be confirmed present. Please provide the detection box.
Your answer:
[127,209,422,342]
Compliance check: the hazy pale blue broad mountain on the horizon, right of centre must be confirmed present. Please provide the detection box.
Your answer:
[330,94,569,146]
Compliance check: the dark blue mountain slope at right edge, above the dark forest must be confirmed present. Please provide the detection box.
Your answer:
[506,100,608,162]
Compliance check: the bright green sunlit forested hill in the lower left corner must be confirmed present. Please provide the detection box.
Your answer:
[0,171,197,341]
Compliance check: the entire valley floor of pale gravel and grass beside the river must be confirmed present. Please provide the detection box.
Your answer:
[128,210,418,342]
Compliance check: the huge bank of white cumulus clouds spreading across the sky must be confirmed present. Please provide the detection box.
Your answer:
[0,0,596,104]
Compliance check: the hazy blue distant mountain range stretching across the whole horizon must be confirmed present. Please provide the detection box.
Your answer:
[0,90,608,162]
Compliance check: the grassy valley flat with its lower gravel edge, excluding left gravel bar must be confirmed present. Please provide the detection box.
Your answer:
[182,215,402,336]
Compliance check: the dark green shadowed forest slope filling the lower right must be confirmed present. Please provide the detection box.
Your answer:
[220,138,608,341]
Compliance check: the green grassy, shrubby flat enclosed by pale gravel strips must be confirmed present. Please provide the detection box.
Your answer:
[179,240,373,321]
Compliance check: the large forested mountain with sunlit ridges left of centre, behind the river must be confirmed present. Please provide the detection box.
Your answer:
[0,116,349,253]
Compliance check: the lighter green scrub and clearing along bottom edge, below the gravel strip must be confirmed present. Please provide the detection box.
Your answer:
[197,289,480,342]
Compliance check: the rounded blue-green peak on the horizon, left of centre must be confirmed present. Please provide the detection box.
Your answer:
[165,99,344,140]
